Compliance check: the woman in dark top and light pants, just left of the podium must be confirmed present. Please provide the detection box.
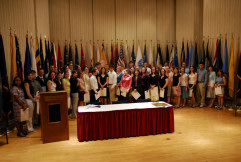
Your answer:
[24,73,38,132]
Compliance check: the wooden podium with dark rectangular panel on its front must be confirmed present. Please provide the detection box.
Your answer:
[40,91,69,143]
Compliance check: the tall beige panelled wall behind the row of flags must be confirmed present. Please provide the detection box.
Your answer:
[0,0,241,82]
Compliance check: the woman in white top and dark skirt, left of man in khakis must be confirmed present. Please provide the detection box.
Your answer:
[188,66,197,108]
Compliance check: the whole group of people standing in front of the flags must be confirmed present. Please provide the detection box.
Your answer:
[11,61,227,137]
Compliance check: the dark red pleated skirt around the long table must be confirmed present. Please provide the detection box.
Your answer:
[77,107,174,141]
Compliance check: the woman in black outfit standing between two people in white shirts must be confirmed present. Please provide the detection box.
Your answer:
[98,67,109,105]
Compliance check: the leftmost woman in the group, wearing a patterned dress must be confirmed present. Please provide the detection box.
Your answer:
[11,76,27,137]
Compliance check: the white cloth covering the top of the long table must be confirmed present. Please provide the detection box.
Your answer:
[78,101,172,113]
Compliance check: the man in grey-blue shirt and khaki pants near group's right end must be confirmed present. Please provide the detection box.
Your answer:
[197,62,208,107]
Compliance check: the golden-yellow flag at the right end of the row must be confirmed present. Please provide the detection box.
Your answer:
[229,38,235,98]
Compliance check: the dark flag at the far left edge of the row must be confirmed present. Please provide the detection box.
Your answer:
[0,34,9,87]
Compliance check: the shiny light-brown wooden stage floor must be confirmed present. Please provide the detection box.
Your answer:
[0,108,241,162]
